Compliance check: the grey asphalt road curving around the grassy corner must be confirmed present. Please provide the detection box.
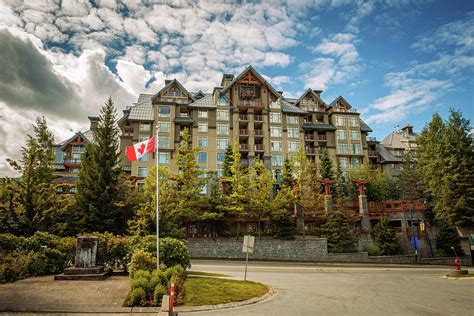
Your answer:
[186,260,474,316]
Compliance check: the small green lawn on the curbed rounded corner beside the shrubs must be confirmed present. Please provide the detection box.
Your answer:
[184,277,268,306]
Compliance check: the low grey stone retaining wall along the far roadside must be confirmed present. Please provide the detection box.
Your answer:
[188,236,328,261]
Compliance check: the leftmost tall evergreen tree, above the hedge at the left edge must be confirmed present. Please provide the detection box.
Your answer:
[8,117,56,235]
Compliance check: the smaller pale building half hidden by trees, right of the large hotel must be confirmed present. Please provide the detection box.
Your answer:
[376,124,418,179]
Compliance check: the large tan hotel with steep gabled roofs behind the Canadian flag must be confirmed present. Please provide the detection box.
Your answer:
[119,66,372,178]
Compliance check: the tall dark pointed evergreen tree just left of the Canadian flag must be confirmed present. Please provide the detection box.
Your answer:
[76,98,125,233]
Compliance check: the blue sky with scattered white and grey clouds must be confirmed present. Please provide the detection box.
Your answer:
[0,0,474,177]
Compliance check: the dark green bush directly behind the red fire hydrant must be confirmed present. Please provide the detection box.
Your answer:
[436,221,464,257]
